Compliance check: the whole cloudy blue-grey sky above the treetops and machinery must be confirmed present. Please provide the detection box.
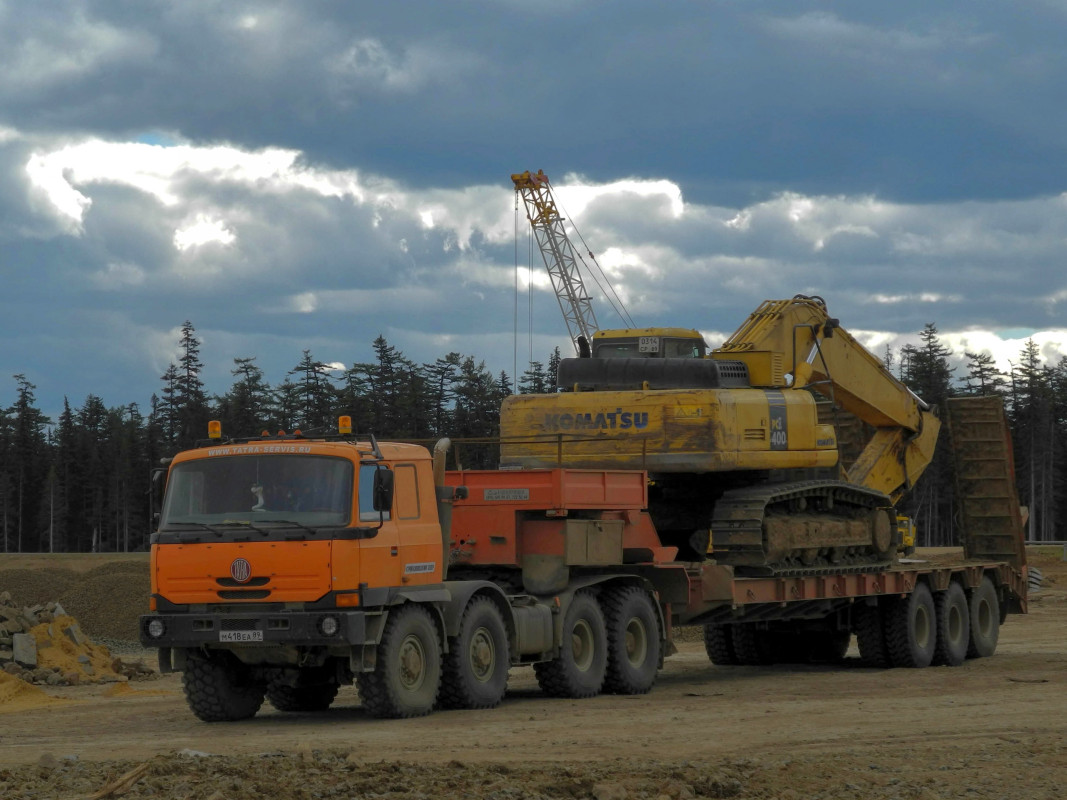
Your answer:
[0,0,1067,422]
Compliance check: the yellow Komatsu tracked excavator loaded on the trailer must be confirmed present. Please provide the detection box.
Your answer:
[500,294,940,574]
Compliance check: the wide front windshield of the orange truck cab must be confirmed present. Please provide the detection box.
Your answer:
[160,454,353,529]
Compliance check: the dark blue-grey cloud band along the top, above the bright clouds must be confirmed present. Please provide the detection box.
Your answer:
[0,0,1067,204]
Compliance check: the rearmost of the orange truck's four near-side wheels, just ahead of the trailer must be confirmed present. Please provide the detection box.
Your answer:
[604,586,659,694]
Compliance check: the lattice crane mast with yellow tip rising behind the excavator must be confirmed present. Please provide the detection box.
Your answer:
[511,170,599,352]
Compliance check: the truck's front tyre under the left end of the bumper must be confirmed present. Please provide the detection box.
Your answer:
[181,652,265,722]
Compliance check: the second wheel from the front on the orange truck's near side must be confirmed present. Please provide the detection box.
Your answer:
[439,597,511,708]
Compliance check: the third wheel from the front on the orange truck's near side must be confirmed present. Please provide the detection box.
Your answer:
[534,592,607,698]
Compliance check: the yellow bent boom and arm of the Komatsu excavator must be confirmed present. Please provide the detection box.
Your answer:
[712,294,941,503]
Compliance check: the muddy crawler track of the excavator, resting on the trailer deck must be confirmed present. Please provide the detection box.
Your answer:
[711,480,896,576]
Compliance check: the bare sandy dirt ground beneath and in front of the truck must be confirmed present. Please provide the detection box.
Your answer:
[0,548,1067,800]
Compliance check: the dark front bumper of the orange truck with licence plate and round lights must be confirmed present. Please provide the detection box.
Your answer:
[140,609,380,647]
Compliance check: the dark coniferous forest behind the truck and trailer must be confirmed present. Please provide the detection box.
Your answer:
[0,322,1067,553]
